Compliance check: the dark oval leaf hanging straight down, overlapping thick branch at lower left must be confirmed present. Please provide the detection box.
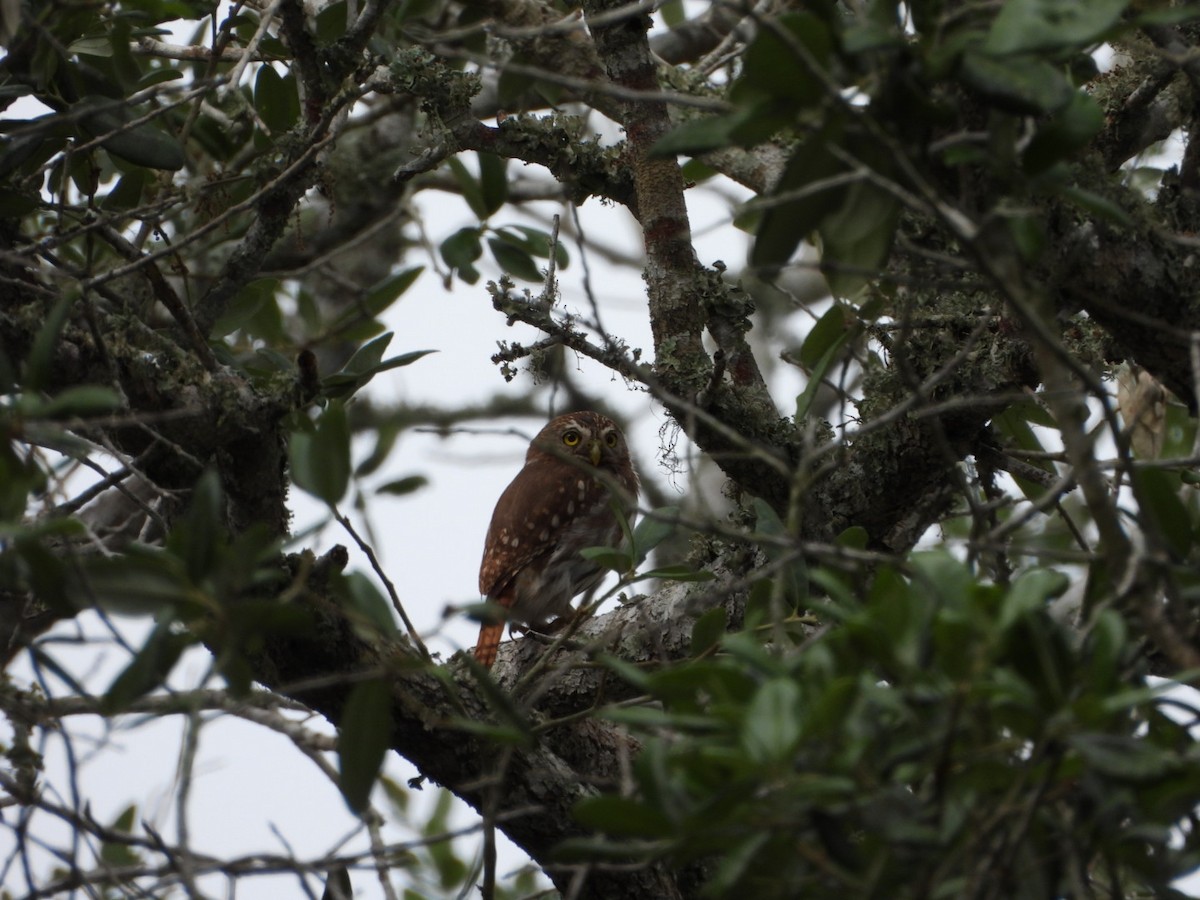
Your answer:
[337,678,391,814]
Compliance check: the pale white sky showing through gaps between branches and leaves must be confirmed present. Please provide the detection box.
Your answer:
[0,7,1195,900]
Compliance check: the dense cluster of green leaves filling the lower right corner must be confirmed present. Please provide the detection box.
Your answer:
[571,552,1200,898]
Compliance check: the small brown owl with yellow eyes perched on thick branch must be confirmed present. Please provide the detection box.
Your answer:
[475,413,637,668]
